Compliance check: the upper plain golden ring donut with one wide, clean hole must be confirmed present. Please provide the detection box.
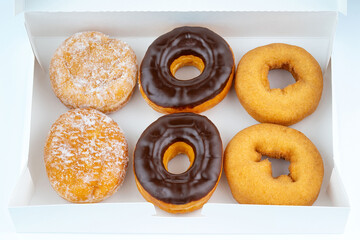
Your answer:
[234,43,323,126]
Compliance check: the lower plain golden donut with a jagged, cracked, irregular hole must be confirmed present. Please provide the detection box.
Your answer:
[224,123,324,206]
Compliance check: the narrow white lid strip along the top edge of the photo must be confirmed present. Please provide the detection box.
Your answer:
[15,0,347,14]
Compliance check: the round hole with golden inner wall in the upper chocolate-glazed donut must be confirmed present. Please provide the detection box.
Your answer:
[170,55,205,81]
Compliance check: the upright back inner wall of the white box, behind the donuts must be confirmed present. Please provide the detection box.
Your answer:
[25,11,337,71]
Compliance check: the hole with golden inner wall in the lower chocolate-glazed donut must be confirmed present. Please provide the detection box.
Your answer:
[163,142,195,174]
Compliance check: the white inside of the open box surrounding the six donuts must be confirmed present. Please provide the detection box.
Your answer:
[11,12,348,232]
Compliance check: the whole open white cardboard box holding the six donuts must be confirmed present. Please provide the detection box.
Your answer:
[9,1,350,233]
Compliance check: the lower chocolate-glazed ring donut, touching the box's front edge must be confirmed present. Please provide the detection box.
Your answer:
[133,113,222,213]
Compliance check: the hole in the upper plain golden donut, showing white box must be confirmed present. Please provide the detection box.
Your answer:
[268,68,296,89]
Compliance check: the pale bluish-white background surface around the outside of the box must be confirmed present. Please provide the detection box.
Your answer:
[0,0,360,239]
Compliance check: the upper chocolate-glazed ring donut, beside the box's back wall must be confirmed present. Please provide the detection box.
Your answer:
[139,27,235,113]
